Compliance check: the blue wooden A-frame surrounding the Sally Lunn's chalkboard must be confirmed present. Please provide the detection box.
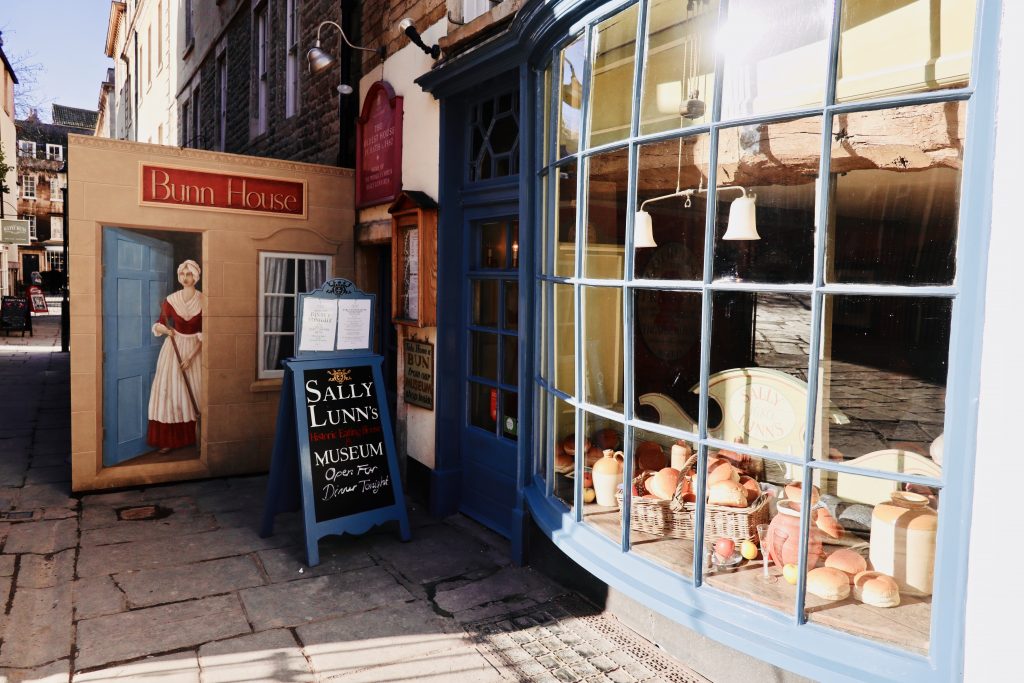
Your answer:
[260,279,412,566]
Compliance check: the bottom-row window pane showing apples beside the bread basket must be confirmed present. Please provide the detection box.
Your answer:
[701,451,798,614]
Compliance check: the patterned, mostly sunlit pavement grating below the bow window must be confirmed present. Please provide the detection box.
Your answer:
[465,595,710,683]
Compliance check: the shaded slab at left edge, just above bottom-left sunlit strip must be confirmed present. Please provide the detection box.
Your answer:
[0,584,72,669]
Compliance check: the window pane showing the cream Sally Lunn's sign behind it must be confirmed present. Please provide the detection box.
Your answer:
[708,292,811,457]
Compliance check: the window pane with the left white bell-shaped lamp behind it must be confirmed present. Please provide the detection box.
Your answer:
[634,133,711,280]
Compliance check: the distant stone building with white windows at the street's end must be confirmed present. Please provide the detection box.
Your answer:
[16,104,98,292]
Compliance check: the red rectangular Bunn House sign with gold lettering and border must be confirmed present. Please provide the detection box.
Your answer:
[139,162,306,218]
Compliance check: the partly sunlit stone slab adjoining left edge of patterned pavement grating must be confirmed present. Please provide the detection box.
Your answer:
[296,601,470,679]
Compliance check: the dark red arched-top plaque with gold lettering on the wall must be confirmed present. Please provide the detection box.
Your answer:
[355,81,402,208]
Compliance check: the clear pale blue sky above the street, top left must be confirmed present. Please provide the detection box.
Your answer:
[0,0,114,121]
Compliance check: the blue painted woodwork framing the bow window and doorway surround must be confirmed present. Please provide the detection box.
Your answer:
[417,0,1001,682]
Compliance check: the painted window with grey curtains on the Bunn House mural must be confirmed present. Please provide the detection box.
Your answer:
[257,252,333,379]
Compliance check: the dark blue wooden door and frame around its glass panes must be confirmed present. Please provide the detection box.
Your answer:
[430,78,531,561]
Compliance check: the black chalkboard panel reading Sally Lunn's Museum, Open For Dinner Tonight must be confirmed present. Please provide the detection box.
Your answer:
[302,366,395,523]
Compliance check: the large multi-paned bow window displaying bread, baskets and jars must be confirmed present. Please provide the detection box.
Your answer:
[534,0,976,655]
